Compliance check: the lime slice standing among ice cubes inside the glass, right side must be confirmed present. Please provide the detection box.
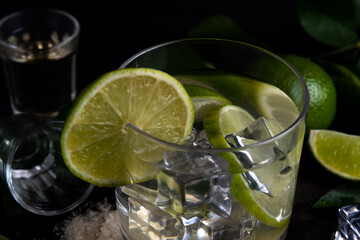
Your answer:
[204,105,296,228]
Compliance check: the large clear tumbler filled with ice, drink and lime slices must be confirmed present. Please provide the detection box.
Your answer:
[115,39,309,240]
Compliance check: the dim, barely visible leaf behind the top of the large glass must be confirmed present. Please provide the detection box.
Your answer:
[188,14,265,47]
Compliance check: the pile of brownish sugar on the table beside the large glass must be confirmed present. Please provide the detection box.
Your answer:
[55,200,123,240]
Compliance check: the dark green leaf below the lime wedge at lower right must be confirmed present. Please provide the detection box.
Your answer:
[313,182,360,208]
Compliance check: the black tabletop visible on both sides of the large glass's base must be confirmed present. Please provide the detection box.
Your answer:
[0,150,339,240]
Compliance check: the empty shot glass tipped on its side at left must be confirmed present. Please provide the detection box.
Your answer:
[0,113,93,216]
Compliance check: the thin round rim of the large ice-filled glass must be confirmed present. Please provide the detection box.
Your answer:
[119,38,310,153]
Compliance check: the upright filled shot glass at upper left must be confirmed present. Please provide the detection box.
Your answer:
[0,9,80,116]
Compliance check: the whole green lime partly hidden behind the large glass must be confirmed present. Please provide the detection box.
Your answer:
[282,54,336,130]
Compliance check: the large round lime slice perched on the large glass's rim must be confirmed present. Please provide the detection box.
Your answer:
[61,68,194,186]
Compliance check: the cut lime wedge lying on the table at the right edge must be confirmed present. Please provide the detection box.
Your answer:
[309,130,360,180]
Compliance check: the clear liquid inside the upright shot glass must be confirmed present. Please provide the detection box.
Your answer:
[3,31,76,114]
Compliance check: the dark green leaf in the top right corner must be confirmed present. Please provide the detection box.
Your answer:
[297,0,358,47]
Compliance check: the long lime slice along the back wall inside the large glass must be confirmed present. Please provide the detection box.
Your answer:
[178,71,299,130]
